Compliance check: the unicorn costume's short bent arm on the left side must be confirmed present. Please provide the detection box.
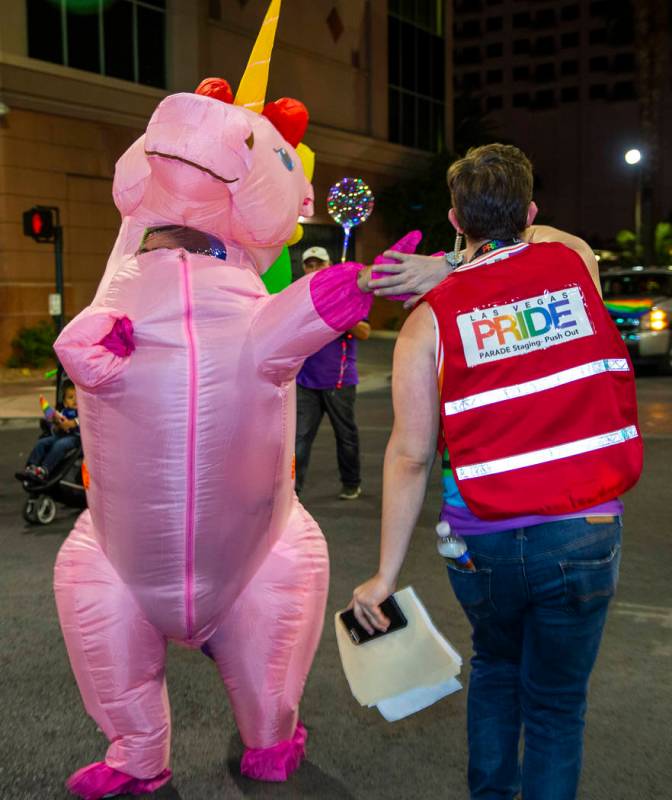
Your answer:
[54,306,135,390]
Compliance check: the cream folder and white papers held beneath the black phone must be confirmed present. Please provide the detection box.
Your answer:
[335,586,462,722]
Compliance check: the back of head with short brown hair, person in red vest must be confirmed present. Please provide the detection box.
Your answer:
[447,144,533,239]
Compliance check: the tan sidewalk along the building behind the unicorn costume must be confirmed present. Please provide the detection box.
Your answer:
[0,331,396,429]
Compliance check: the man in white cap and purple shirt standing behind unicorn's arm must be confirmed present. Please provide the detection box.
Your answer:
[295,247,371,500]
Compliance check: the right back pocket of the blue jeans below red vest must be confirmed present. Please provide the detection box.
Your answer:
[560,544,621,614]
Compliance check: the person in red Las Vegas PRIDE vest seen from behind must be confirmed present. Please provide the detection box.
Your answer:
[351,144,642,800]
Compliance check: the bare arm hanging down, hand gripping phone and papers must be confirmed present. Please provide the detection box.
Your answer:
[352,305,439,633]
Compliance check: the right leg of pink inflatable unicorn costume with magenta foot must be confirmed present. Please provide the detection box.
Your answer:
[208,503,329,781]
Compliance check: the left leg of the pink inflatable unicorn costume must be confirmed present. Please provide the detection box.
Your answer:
[54,511,170,798]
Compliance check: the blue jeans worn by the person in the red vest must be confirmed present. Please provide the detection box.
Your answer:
[448,517,621,800]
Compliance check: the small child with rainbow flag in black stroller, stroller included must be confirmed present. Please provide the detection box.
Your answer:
[16,380,86,525]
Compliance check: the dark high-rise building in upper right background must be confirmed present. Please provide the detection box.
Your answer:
[454,0,672,246]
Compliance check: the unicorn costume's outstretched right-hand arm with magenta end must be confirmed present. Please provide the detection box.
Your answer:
[252,264,373,384]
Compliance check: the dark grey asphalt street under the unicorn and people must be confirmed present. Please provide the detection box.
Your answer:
[0,344,672,800]
